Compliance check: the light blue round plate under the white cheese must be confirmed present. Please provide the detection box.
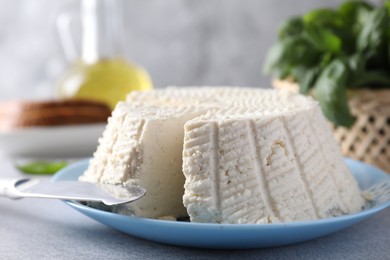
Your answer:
[53,159,390,249]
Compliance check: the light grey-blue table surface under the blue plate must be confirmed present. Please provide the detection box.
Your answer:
[0,157,390,260]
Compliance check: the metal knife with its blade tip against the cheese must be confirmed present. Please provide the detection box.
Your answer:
[0,178,146,206]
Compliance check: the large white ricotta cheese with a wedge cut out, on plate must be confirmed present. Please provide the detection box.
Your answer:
[81,87,364,224]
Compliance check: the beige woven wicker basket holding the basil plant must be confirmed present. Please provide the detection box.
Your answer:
[273,80,390,173]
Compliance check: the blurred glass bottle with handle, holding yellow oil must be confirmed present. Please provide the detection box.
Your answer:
[57,0,152,109]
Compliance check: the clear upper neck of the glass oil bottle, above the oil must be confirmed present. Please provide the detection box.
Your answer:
[81,0,126,63]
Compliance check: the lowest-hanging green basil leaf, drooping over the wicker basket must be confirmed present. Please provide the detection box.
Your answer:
[314,59,355,127]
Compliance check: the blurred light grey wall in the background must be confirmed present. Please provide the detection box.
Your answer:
[0,0,380,100]
